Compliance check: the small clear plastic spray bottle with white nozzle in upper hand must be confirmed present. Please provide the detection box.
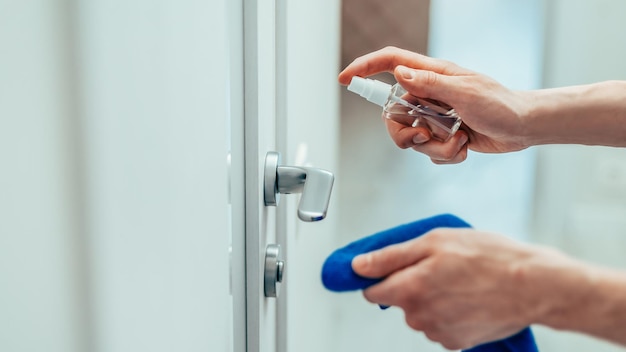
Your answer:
[348,76,461,142]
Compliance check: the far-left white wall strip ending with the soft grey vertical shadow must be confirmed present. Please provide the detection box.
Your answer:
[0,0,88,352]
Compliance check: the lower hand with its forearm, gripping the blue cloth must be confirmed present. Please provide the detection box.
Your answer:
[352,228,626,349]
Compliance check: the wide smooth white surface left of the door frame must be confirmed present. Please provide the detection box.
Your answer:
[0,0,232,352]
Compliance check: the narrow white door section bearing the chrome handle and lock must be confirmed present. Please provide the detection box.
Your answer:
[230,0,340,352]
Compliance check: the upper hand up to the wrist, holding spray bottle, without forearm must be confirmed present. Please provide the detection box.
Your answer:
[338,47,529,164]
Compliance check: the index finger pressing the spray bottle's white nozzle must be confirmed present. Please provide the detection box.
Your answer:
[339,47,467,85]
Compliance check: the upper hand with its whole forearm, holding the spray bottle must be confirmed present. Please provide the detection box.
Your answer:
[339,47,626,164]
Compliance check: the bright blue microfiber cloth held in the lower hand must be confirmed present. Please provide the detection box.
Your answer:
[322,214,538,352]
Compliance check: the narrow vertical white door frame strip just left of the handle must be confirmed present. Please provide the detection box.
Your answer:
[239,0,277,352]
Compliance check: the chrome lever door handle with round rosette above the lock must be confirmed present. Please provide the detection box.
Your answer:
[264,152,335,221]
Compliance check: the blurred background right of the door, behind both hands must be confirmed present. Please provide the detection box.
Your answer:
[338,0,626,351]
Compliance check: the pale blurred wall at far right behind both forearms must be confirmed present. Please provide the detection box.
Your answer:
[532,0,626,352]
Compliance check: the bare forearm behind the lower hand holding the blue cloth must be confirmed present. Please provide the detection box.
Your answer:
[529,250,626,346]
